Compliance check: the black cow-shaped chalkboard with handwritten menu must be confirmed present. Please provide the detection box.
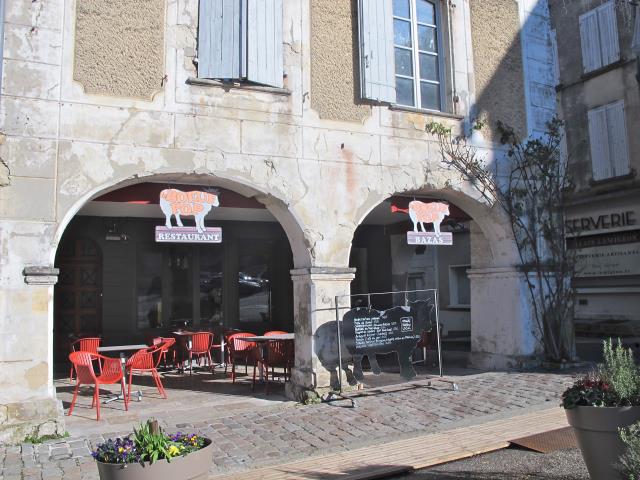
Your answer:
[341,301,434,379]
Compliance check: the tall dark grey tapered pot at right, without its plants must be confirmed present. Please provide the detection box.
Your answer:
[565,407,640,480]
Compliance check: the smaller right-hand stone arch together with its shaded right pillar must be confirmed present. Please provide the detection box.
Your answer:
[344,178,540,368]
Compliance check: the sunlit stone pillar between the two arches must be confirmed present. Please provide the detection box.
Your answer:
[287,267,355,400]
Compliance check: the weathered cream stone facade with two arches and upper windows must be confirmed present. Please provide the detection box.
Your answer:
[0,0,553,441]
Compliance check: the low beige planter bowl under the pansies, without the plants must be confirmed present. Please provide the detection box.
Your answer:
[96,438,213,480]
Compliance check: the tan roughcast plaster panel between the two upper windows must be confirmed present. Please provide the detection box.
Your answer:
[311,0,371,122]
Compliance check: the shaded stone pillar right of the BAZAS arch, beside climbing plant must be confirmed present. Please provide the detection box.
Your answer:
[468,267,540,369]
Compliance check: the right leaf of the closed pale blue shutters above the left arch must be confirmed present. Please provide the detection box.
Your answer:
[247,0,284,87]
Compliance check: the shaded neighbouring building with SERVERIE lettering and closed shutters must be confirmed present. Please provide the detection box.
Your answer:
[550,1,640,336]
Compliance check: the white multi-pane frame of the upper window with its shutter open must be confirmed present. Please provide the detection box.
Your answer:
[393,0,446,112]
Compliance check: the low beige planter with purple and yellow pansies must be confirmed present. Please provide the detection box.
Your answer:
[92,420,212,480]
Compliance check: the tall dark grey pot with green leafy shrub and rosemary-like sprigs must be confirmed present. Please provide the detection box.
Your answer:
[562,339,640,480]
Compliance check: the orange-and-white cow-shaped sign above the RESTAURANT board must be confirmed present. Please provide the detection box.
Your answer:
[160,188,220,233]
